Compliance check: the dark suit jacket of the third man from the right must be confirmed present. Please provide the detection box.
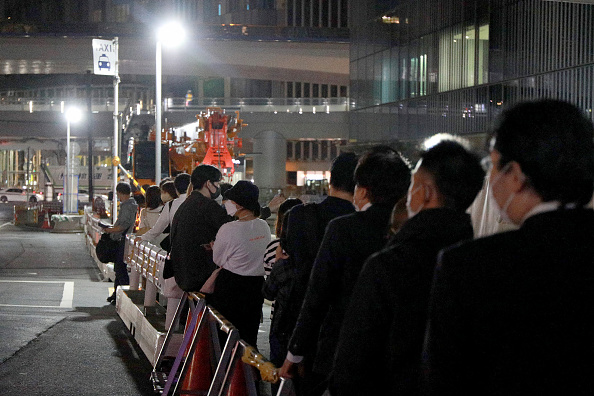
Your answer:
[289,204,392,375]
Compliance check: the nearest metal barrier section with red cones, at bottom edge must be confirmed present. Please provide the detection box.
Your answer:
[151,293,295,396]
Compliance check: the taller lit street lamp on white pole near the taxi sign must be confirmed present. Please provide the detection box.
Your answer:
[155,22,185,184]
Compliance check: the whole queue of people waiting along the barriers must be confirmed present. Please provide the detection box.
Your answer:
[107,100,594,396]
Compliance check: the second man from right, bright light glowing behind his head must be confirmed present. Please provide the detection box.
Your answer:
[330,137,484,395]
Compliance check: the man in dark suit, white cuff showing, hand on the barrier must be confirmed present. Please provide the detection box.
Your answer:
[281,147,410,395]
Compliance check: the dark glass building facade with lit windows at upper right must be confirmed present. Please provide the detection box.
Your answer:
[349,0,594,142]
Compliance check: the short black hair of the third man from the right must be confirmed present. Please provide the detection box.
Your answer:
[355,146,410,205]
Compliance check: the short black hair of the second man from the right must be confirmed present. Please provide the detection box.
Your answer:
[421,140,485,211]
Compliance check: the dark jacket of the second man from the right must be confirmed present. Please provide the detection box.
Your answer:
[331,208,473,395]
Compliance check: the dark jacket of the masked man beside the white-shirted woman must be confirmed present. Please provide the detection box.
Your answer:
[170,191,231,292]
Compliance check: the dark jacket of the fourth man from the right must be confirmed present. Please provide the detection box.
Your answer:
[278,197,355,344]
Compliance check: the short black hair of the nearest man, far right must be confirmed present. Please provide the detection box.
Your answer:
[493,99,594,205]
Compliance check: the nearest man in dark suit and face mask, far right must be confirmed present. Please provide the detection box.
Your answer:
[425,100,594,395]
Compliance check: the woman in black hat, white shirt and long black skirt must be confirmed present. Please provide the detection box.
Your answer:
[207,181,271,346]
